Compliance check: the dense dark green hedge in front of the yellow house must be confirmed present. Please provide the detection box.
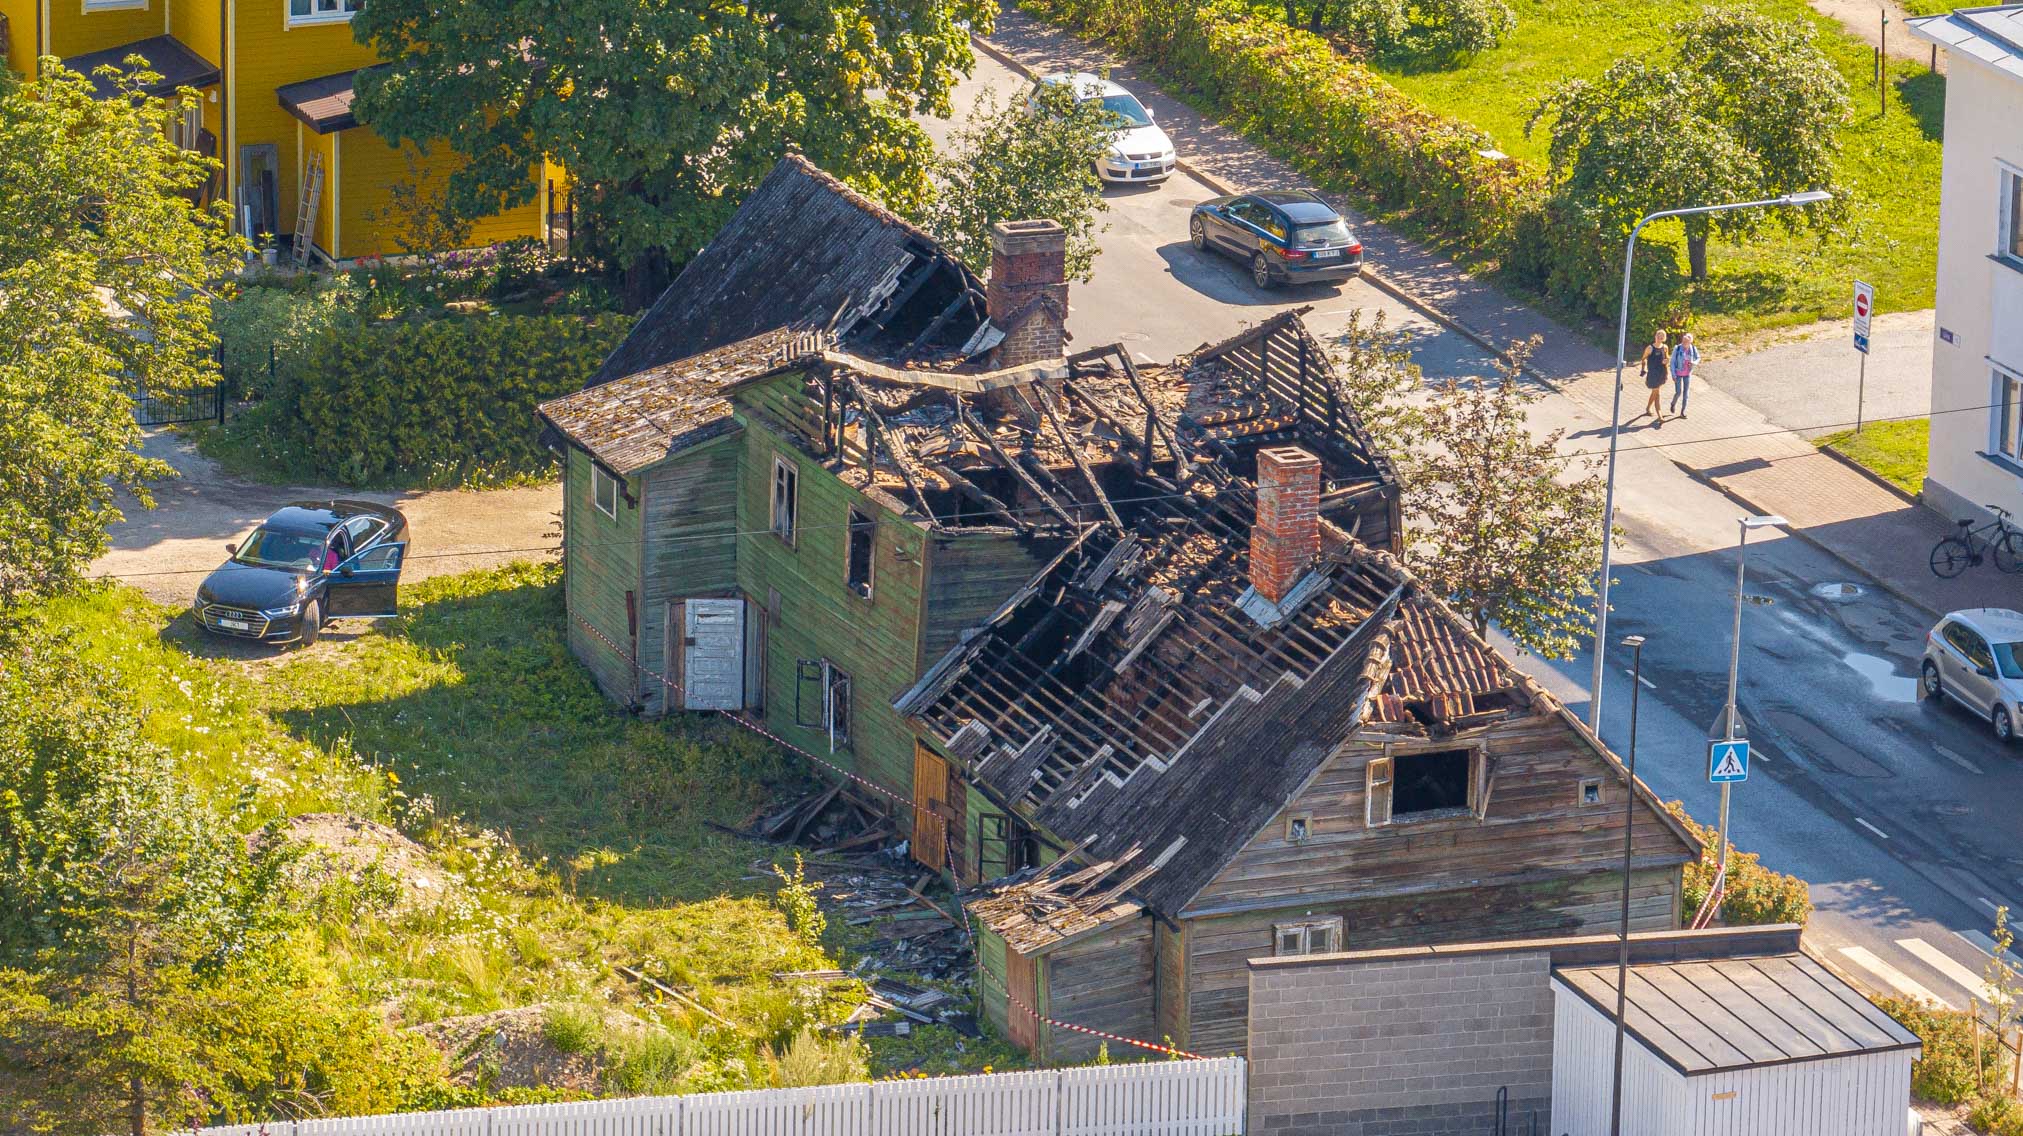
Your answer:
[250,315,631,485]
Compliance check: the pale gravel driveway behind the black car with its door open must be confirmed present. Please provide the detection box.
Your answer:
[91,429,562,604]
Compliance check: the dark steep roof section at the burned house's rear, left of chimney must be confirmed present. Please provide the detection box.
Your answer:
[591,156,983,386]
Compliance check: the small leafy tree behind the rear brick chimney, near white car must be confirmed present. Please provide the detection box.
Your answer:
[920,83,1113,281]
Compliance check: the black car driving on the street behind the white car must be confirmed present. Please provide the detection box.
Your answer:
[1188,190,1364,289]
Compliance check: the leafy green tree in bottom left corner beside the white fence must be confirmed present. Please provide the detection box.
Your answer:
[0,650,445,1136]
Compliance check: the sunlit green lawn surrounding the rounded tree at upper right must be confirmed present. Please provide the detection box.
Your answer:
[1380,0,1944,336]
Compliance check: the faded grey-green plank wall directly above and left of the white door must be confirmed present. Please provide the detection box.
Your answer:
[639,435,744,714]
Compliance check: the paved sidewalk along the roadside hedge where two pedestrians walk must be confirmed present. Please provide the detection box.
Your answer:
[989,8,2023,612]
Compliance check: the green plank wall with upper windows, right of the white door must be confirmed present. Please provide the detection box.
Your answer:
[736,374,927,796]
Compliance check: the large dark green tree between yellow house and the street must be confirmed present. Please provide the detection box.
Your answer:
[352,0,995,299]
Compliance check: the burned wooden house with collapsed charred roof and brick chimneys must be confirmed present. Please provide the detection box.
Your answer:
[542,158,1695,1059]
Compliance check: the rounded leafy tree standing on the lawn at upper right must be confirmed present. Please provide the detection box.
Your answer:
[1525,8,1849,281]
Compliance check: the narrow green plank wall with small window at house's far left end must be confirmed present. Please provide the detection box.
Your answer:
[562,447,639,703]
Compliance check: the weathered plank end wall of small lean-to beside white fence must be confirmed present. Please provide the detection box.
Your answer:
[1042,916,1159,1065]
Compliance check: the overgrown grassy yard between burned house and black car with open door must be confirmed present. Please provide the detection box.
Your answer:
[23,564,1018,1092]
